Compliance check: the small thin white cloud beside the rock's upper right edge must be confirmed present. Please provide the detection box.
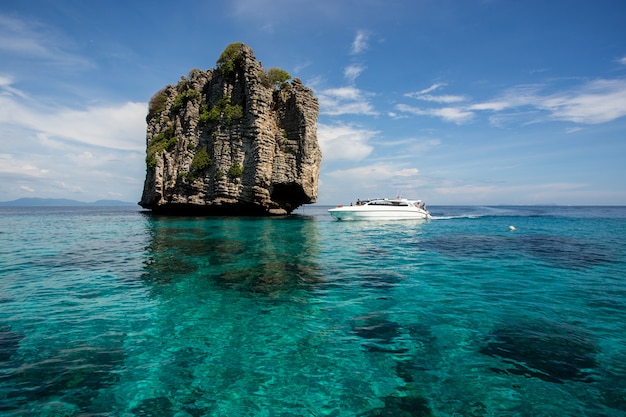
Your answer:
[317,86,378,116]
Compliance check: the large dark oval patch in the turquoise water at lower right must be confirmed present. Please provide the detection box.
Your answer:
[479,322,600,384]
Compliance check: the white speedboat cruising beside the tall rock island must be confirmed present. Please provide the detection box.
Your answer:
[328,198,431,220]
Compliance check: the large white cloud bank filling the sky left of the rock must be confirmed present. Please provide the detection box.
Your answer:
[0,76,147,201]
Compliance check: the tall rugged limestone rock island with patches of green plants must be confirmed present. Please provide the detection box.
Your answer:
[139,44,322,215]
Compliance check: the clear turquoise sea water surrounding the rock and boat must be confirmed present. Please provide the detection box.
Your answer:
[0,206,626,417]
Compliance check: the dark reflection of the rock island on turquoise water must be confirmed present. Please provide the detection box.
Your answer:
[144,216,320,297]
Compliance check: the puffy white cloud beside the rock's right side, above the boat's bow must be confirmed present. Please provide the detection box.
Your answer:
[317,124,378,161]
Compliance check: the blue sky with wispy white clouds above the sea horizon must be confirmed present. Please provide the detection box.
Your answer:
[0,0,626,205]
